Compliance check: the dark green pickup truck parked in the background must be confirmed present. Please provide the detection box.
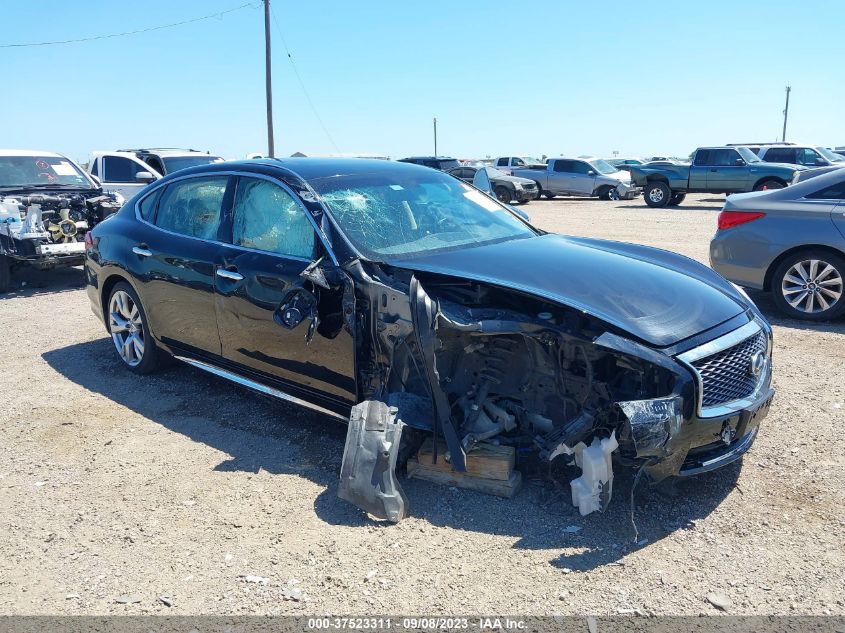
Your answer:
[631,147,804,208]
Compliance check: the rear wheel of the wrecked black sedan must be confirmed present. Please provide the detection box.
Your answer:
[105,281,163,374]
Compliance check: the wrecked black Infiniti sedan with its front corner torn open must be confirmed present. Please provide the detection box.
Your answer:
[86,158,774,521]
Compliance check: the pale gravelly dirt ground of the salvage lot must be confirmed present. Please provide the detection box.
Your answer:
[0,197,845,615]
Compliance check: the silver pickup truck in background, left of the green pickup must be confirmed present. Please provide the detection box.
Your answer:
[512,158,642,200]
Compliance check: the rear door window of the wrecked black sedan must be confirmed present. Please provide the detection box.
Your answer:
[155,176,229,240]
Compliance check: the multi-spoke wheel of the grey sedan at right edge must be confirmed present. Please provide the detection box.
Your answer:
[771,249,845,321]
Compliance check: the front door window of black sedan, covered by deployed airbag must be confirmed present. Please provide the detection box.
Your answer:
[232,178,314,259]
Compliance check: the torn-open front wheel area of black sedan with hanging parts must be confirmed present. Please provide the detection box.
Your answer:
[332,266,724,520]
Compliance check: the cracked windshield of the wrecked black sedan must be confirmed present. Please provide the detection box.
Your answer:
[309,169,536,261]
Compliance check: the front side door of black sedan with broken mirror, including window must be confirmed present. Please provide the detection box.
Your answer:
[215,176,356,413]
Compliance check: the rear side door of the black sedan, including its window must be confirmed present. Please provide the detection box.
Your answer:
[134,175,230,356]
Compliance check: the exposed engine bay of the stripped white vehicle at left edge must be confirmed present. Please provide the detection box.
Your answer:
[0,191,121,268]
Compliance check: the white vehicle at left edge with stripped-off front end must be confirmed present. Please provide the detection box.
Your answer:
[0,149,123,292]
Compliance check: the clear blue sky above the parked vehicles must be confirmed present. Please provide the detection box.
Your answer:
[0,0,845,159]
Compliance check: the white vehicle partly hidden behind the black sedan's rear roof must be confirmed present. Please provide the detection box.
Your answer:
[88,148,223,200]
